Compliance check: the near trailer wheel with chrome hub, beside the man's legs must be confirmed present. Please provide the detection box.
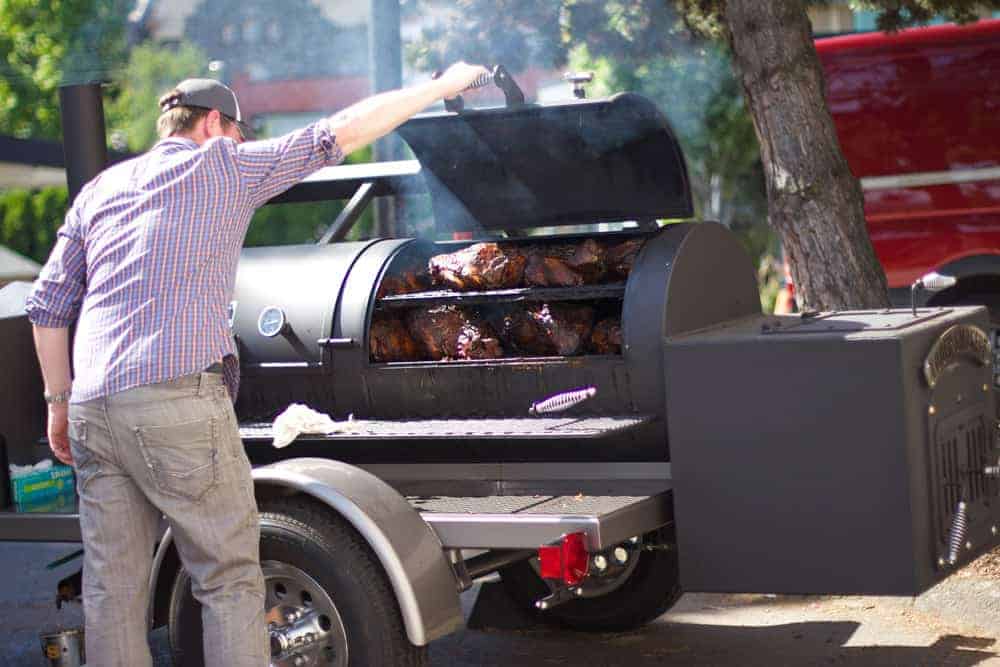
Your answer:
[169,496,427,667]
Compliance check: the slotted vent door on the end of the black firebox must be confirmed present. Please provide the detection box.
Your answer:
[931,412,998,544]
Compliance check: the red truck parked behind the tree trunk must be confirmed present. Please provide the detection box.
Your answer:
[784,20,1000,322]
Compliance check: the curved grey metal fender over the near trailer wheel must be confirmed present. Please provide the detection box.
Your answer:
[149,458,463,646]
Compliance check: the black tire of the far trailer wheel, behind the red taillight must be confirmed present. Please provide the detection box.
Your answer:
[500,529,681,632]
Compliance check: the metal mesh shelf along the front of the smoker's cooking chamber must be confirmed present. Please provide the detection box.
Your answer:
[240,415,653,441]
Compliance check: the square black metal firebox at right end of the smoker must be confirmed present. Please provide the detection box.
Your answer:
[665,309,1000,595]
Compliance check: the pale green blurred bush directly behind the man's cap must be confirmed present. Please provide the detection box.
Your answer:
[105,43,208,152]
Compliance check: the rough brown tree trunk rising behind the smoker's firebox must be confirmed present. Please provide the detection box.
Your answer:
[724,0,889,310]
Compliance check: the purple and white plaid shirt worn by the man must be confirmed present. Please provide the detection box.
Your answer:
[26,120,343,403]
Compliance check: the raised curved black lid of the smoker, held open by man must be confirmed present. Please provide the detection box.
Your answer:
[397,93,693,231]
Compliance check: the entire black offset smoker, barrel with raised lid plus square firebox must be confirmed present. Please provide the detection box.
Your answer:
[225,90,1000,594]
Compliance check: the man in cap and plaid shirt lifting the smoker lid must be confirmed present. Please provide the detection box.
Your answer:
[27,63,486,667]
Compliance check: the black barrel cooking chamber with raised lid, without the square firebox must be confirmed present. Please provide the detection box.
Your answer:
[234,95,760,470]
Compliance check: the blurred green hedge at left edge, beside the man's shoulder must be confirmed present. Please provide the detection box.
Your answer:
[0,187,67,263]
